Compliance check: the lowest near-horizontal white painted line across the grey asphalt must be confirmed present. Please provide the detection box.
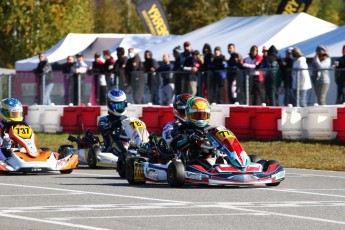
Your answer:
[47,212,269,221]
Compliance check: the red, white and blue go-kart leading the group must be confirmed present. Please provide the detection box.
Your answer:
[127,126,285,187]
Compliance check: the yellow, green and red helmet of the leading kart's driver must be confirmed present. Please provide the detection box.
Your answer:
[186,97,211,128]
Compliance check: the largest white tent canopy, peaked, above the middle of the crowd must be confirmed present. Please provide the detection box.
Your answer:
[143,13,337,60]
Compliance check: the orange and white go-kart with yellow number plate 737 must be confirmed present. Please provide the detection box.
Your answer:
[0,122,78,174]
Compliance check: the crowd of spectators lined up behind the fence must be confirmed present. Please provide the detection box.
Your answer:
[34,41,345,107]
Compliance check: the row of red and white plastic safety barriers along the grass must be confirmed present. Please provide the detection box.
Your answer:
[24,105,345,140]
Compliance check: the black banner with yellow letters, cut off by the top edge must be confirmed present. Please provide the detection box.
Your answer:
[277,0,312,14]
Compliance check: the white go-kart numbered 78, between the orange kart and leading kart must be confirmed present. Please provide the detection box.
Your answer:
[59,117,149,178]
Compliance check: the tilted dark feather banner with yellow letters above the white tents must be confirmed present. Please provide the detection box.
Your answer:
[136,0,170,35]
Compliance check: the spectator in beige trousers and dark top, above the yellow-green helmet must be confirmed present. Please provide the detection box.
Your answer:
[183,50,202,96]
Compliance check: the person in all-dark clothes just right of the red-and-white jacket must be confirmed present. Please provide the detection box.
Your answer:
[261,45,278,106]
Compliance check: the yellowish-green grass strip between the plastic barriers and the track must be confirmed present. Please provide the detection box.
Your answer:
[36,133,345,171]
